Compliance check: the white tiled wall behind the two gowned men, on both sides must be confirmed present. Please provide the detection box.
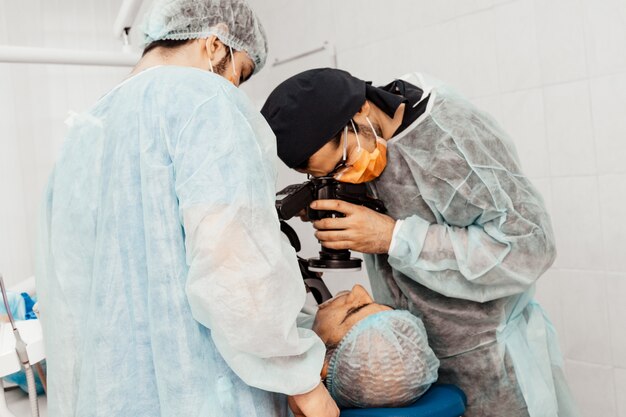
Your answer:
[0,0,626,417]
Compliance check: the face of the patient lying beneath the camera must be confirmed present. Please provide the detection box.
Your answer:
[313,285,392,346]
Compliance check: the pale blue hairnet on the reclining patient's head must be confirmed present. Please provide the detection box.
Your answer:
[326,310,439,408]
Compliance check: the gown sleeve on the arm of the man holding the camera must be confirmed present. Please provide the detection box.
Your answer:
[388,102,556,302]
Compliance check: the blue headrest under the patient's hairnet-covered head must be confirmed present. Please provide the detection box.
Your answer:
[341,384,467,417]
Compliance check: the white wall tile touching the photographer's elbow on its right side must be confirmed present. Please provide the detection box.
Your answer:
[552,177,605,270]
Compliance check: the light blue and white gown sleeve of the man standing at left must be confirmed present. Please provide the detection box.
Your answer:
[174,94,325,395]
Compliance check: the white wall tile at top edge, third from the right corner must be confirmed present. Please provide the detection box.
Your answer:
[495,0,541,92]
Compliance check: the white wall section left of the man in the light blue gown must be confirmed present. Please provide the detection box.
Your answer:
[0,0,129,285]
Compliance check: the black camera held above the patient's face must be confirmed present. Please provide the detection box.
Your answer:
[276,177,386,272]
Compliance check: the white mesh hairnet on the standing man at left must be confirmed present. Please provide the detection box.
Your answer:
[142,0,267,73]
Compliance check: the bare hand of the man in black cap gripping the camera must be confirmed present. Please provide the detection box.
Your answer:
[311,200,396,253]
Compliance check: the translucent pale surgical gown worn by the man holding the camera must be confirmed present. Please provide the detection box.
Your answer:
[366,74,578,417]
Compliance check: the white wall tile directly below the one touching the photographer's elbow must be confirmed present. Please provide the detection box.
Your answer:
[560,270,612,365]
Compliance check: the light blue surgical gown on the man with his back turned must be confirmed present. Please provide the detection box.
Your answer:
[37,67,324,417]
